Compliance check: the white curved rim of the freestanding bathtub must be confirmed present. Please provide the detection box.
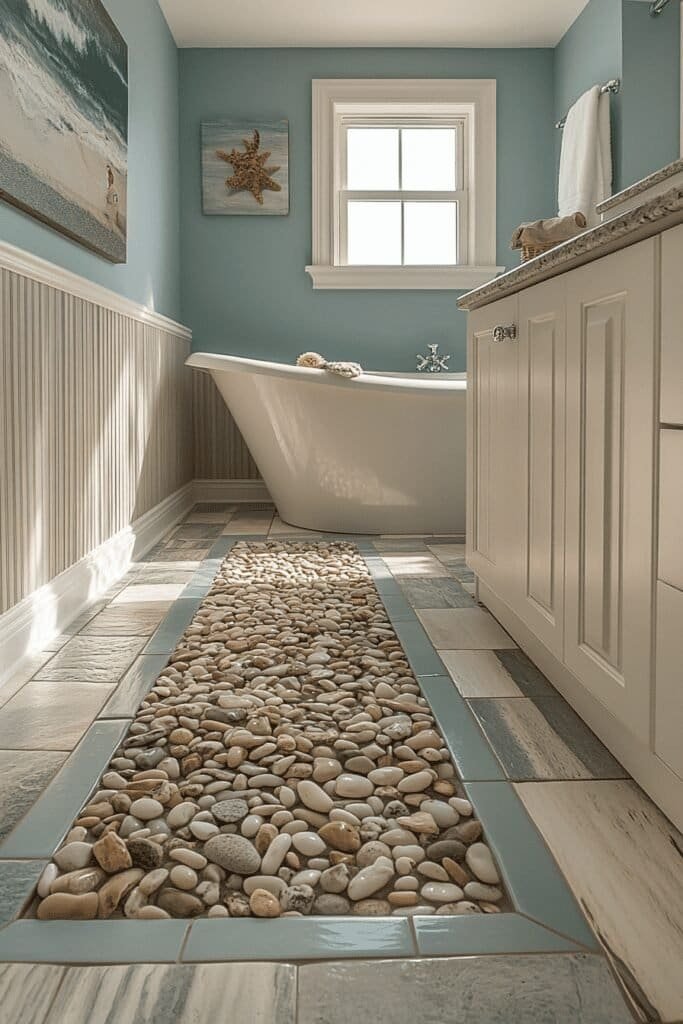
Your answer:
[185,352,467,394]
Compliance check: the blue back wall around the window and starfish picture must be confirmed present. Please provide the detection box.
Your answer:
[180,49,554,370]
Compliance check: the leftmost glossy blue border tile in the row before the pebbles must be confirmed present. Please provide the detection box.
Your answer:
[0,918,188,964]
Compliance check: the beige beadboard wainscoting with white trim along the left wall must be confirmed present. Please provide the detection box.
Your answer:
[0,244,195,679]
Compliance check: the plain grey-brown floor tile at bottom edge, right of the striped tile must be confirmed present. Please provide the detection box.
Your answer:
[298,953,632,1024]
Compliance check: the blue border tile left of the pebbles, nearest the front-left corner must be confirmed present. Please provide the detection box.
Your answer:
[0,719,129,864]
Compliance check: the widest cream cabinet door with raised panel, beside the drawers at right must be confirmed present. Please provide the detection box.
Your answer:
[565,240,657,741]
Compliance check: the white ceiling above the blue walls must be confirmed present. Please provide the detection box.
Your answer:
[160,0,588,46]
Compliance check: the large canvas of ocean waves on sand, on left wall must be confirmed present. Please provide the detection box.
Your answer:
[0,0,128,263]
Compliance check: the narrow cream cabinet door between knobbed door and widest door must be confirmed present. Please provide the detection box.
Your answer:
[515,278,566,659]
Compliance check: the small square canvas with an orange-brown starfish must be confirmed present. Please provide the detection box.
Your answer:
[202,120,290,215]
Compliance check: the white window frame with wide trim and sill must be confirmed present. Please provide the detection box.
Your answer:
[306,79,505,291]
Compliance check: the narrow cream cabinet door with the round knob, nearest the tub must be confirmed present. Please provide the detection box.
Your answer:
[467,297,519,597]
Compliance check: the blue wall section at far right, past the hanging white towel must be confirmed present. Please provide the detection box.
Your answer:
[621,0,681,187]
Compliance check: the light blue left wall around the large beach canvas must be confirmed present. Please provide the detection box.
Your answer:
[0,0,180,318]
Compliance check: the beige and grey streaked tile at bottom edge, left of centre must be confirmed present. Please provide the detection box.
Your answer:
[47,964,296,1024]
